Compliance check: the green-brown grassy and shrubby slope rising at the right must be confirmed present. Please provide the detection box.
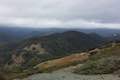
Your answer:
[75,44,120,74]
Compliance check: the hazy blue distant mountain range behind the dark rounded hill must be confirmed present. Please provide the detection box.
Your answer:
[0,26,120,45]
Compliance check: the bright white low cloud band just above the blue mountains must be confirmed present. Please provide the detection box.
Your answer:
[0,18,120,29]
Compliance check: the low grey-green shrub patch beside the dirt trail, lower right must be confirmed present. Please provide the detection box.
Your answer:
[74,57,120,74]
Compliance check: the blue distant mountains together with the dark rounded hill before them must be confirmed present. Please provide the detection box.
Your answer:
[0,26,120,63]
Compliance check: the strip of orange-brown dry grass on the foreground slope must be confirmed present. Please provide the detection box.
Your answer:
[34,53,89,72]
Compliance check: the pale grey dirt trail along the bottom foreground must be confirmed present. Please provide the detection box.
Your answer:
[23,64,120,80]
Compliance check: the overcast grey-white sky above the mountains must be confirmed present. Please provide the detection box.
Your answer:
[0,0,120,28]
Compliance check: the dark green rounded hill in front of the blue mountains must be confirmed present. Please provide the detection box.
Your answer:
[20,31,104,56]
